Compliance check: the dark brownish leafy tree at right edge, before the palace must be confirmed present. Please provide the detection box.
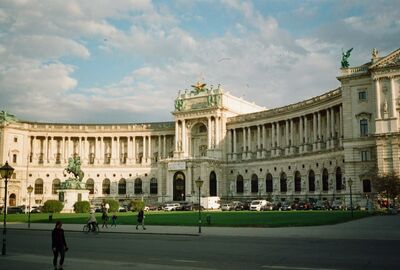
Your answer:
[373,171,400,209]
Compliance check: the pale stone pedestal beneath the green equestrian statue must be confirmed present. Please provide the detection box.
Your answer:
[58,178,89,213]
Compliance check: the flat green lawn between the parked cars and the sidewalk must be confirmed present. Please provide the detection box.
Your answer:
[2,211,373,227]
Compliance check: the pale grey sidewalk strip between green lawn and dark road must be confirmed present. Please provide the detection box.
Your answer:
[0,215,400,240]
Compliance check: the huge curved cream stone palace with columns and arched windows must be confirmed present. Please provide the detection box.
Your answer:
[0,49,400,207]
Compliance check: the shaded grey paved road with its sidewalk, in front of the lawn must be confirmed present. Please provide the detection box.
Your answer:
[0,216,400,270]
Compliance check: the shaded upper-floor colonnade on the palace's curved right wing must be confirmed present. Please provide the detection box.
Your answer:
[227,105,343,161]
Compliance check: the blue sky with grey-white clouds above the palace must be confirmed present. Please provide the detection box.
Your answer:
[0,0,400,123]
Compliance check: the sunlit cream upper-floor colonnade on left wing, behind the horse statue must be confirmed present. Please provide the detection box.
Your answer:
[30,134,173,165]
